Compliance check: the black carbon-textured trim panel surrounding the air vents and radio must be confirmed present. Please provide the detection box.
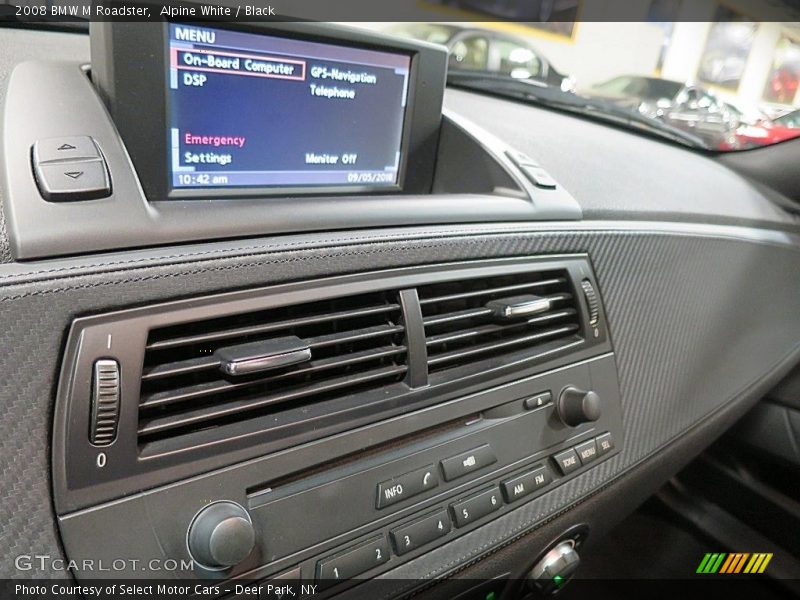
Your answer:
[0,225,800,577]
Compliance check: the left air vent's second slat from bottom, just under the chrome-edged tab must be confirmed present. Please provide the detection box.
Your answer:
[139,346,406,409]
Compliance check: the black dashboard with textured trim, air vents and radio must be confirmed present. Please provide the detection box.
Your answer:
[0,25,800,598]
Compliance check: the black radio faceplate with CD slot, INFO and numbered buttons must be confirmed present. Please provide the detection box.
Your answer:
[60,353,623,592]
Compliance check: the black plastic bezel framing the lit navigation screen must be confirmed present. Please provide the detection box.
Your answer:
[92,19,447,201]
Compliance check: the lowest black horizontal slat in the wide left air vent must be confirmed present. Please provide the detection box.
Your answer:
[138,365,407,437]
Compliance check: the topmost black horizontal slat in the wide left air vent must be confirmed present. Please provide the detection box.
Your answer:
[145,303,400,351]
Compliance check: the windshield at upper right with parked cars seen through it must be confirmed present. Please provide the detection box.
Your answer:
[376,18,800,151]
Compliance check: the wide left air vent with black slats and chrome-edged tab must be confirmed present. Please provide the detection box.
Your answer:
[138,292,407,445]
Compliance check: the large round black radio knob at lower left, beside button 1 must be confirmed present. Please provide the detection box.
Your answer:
[188,501,256,569]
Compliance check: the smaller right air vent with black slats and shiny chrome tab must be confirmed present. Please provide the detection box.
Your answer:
[418,270,581,373]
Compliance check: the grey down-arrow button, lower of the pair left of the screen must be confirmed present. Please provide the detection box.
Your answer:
[36,160,111,202]
